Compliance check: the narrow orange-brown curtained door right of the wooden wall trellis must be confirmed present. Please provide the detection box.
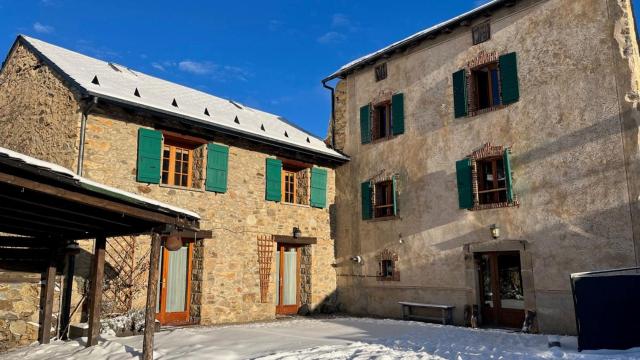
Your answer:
[275,243,300,315]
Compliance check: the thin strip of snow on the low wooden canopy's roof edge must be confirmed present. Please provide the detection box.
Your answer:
[0,147,200,219]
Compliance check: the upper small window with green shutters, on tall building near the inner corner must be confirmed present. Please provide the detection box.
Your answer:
[360,93,404,144]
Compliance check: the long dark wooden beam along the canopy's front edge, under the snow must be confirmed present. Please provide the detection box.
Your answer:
[0,173,194,228]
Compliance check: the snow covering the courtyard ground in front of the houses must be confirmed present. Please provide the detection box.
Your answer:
[3,318,640,360]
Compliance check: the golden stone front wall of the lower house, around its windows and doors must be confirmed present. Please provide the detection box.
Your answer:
[76,104,336,324]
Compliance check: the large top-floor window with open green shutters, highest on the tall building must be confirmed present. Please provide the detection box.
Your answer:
[453,52,520,118]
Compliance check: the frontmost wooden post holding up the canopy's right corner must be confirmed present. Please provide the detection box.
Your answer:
[142,233,161,360]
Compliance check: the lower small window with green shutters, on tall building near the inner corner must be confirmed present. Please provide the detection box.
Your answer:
[361,175,398,220]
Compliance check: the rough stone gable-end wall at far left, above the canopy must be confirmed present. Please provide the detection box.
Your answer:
[0,41,80,171]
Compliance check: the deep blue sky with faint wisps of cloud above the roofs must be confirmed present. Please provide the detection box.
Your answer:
[0,0,637,137]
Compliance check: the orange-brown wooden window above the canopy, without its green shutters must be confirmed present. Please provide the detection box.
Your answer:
[160,135,198,189]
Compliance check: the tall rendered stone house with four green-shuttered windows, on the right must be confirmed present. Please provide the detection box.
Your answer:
[323,0,640,333]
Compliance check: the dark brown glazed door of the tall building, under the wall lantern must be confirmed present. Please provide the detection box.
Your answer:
[477,252,524,328]
